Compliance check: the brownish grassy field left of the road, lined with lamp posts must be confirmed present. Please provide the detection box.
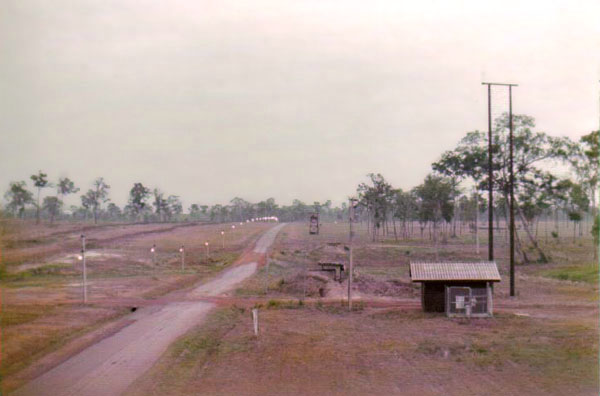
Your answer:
[0,222,269,391]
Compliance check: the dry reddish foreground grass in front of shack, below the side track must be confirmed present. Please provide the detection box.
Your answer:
[125,304,598,395]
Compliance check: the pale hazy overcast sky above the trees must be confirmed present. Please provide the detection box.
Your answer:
[0,0,600,208]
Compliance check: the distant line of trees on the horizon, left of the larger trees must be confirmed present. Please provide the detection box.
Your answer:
[5,175,345,224]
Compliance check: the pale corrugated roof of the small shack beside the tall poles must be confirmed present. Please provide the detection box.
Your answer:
[410,261,500,282]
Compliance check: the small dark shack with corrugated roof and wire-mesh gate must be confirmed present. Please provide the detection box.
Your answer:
[410,261,500,317]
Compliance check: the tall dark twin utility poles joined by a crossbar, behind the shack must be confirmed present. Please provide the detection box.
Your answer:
[481,82,518,296]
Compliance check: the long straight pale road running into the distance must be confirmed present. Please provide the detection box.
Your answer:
[13,224,284,396]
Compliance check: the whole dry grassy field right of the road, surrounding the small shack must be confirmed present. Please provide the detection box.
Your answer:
[124,224,599,395]
